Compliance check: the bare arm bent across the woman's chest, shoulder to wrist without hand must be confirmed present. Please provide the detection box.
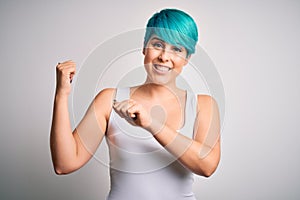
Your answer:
[147,95,220,177]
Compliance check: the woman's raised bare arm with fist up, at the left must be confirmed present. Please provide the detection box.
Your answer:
[50,61,114,174]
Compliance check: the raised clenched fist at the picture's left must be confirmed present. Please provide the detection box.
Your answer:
[56,60,76,95]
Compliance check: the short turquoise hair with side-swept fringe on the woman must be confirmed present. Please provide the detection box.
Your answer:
[144,9,198,56]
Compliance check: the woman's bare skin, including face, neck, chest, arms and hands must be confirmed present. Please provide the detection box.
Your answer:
[50,35,220,177]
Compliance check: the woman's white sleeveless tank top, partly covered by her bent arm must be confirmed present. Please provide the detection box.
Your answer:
[106,88,197,200]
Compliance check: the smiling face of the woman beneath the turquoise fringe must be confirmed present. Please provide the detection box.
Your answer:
[143,35,189,84]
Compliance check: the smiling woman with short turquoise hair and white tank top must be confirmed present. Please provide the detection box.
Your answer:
[50,9,220,200]
